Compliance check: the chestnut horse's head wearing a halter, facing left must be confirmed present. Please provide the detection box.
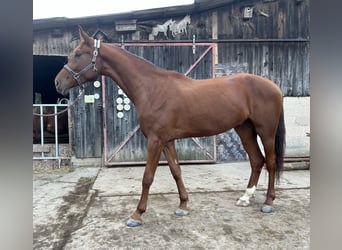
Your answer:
[55,27,100,96]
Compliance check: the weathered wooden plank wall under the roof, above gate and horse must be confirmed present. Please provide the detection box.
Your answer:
[33,0,310,96]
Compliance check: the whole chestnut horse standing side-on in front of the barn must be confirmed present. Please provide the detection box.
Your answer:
[55,27,285,227]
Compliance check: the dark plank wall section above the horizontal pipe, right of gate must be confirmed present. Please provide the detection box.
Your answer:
[217,0,310,39]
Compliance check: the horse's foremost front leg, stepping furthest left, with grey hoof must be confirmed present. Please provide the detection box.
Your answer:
[127,138,163,227]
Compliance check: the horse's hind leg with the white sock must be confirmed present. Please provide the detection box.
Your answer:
[235,120,265,206]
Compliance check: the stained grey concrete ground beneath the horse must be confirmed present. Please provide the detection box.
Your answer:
[33,162,310,250]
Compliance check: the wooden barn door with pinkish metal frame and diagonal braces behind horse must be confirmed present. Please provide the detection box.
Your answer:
[102,43,216,166]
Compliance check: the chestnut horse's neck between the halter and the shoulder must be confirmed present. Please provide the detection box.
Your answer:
[99,44,164,104]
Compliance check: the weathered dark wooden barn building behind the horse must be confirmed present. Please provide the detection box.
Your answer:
[33,0,310,166]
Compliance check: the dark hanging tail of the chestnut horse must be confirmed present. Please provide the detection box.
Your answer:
[275,105,286,182]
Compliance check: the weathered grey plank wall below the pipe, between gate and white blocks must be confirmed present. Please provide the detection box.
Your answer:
[218,42,310,96]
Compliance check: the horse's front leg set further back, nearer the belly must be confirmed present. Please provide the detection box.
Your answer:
[163,141,189,216]
